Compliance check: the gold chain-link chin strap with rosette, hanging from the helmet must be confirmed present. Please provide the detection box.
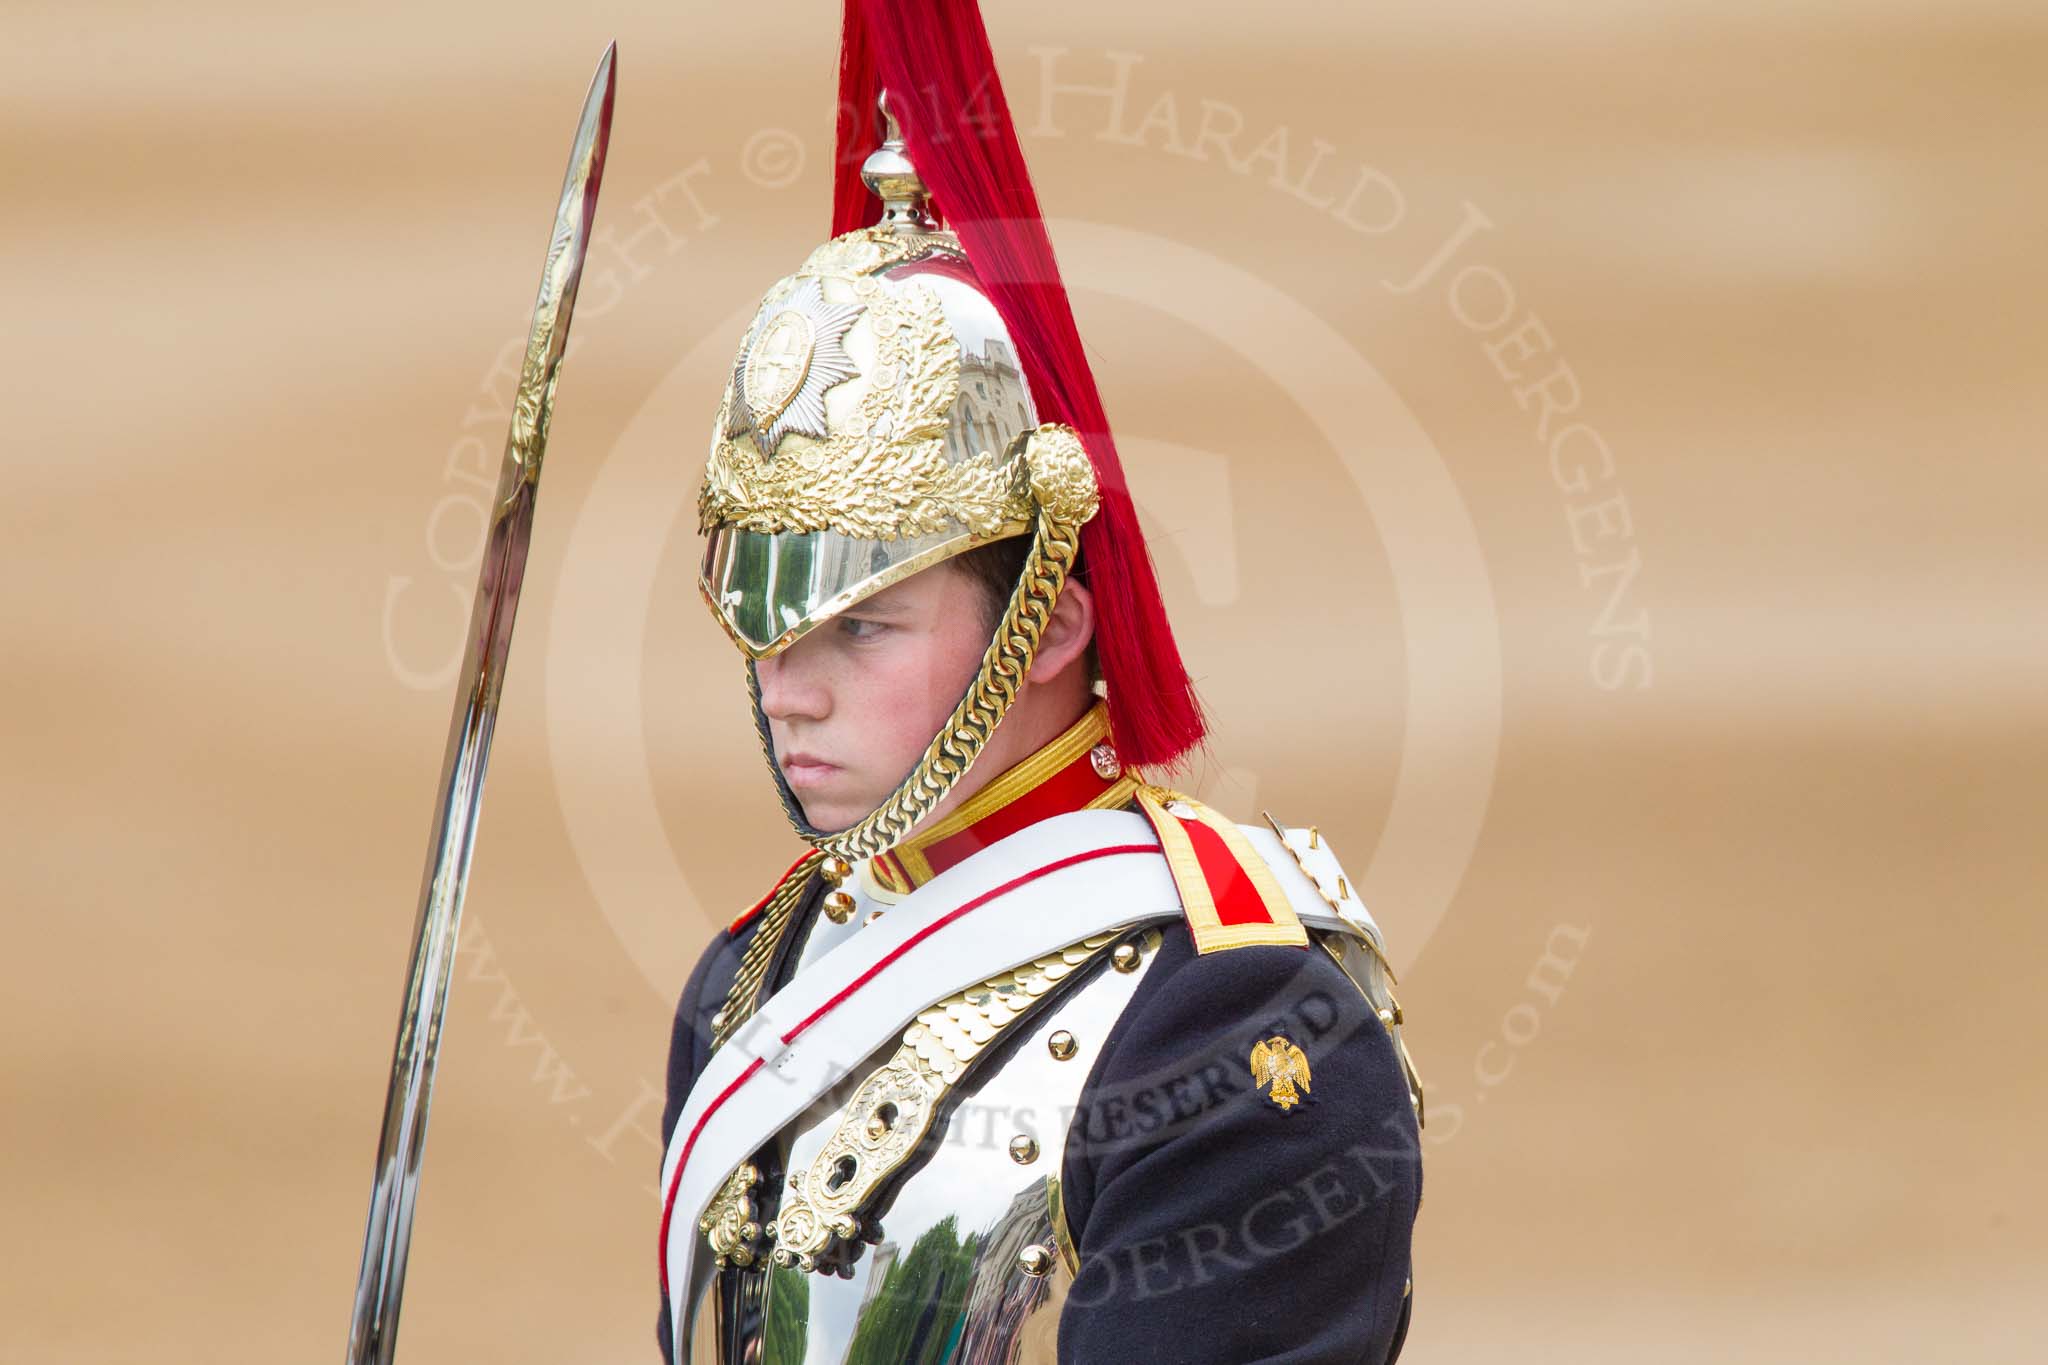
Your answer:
[748,424,1100,862]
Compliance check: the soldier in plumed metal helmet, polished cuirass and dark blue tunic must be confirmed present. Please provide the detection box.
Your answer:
[657,0,1423,1365]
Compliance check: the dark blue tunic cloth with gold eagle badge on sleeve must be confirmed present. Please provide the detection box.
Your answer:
[657,879,1421,1365]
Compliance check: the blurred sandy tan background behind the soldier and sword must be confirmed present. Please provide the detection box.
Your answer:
[0,0,2048,1363]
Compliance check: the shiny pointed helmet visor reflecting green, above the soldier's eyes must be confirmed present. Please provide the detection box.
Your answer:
[702,524,1026,659]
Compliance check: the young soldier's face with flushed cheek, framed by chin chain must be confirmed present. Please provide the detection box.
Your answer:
[756,561,989,831]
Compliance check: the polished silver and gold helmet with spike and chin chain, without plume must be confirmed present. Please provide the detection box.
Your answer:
[698,108,1098,857]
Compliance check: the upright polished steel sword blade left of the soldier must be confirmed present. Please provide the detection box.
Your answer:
[348,43,618,1365]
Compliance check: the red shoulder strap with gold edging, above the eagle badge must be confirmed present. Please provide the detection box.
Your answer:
[1137,786,1309,954]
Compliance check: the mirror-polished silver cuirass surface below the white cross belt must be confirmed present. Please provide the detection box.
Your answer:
[684,931,1159,1365]
